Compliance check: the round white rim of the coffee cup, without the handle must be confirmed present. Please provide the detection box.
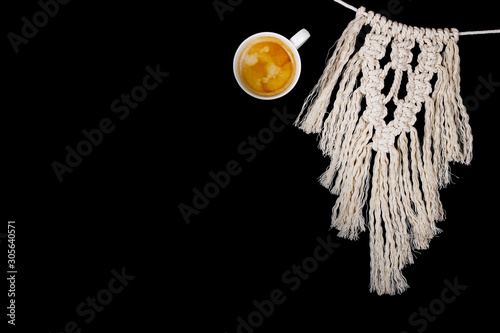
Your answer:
[233,32,302,100]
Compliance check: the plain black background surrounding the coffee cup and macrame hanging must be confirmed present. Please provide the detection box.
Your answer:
[4,0,500,333]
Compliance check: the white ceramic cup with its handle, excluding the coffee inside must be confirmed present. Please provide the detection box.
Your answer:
[233,29,311,100]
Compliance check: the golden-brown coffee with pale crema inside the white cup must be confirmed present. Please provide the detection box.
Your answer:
[238,37,296,97]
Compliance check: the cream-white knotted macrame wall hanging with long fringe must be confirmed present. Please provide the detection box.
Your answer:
[295,1,498,295]
